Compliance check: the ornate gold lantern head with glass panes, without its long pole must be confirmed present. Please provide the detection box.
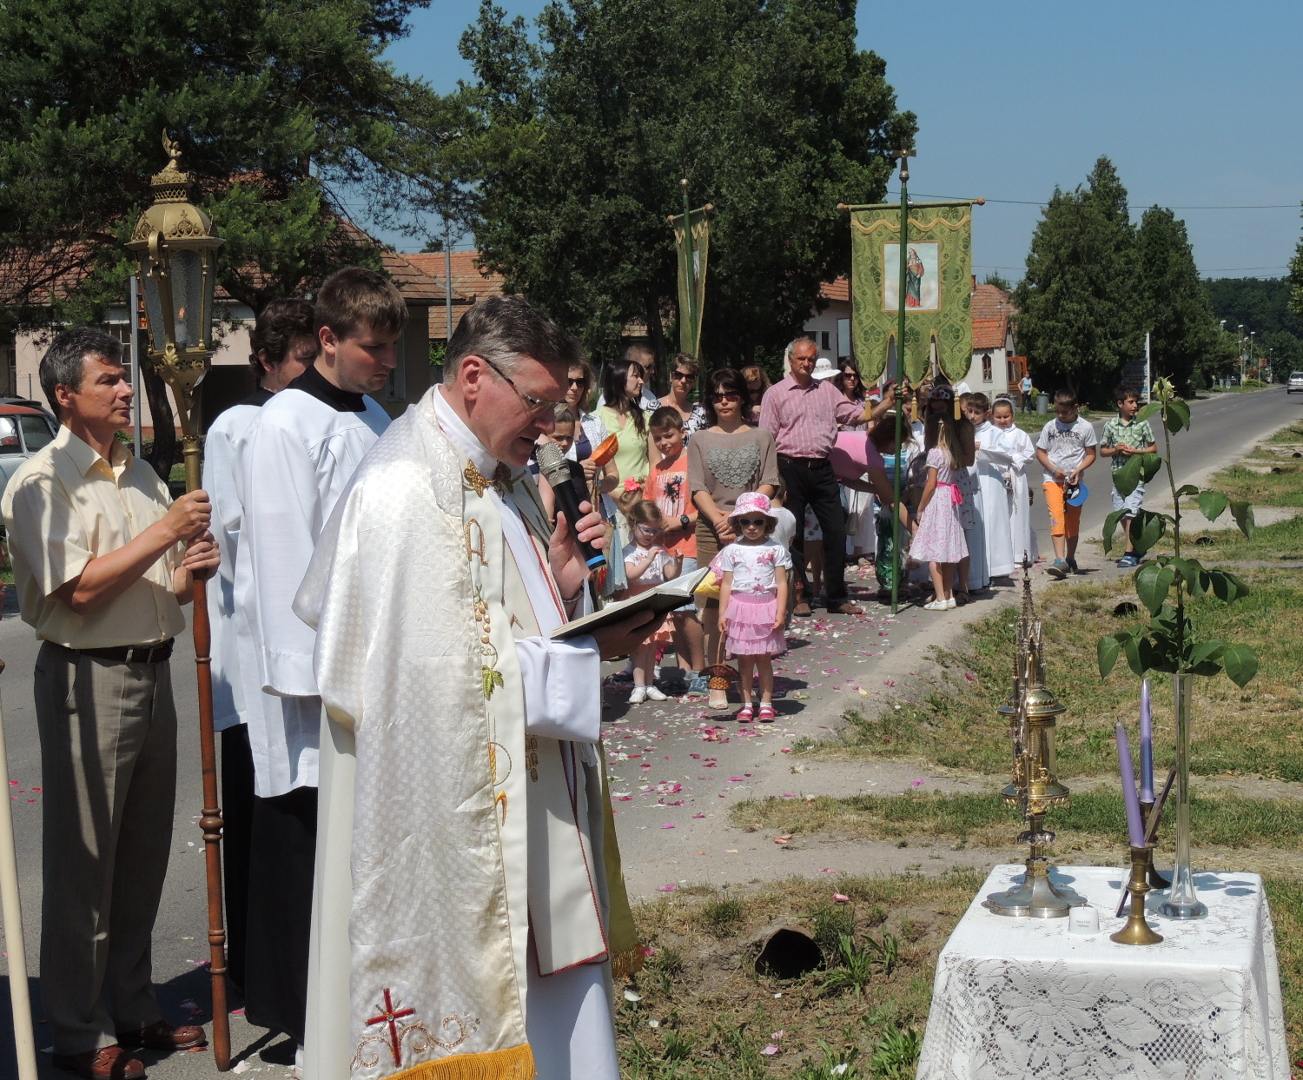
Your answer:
[126,132,222,450]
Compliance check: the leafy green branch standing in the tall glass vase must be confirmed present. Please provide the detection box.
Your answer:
[1096,379,1257,687]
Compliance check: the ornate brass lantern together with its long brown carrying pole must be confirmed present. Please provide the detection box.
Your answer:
[126,132,231,1072]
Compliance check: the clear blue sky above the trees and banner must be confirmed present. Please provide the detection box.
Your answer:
[377,0,1303,281]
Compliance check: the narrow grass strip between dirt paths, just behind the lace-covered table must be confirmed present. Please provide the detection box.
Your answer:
[731,788,1303,851]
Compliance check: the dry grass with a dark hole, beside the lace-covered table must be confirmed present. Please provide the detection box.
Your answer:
[616,870,1303,1080]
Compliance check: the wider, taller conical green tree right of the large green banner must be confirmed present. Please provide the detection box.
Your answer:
[1015,158,1144,400]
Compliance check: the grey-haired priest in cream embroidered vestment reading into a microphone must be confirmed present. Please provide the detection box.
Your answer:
[294,297,650,1080]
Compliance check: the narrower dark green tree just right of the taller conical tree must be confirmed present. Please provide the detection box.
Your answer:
[1136,206,1220,393]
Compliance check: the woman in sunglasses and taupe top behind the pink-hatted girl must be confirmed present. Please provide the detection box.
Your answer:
[688,367,778,709]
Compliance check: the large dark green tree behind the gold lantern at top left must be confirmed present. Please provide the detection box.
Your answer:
[0,0,459,322]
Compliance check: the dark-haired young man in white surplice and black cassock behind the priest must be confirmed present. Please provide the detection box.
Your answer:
[235,267,407,1058]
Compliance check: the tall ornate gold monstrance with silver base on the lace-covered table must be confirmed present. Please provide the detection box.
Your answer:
[985,559,1085,918]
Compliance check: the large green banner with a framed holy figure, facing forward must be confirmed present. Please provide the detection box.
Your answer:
[850,202,972,383]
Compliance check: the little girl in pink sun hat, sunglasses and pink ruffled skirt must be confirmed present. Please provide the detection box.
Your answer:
[710,491,792,723]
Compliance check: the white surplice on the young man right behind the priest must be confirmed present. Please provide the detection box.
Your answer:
[235,386,390,799]
